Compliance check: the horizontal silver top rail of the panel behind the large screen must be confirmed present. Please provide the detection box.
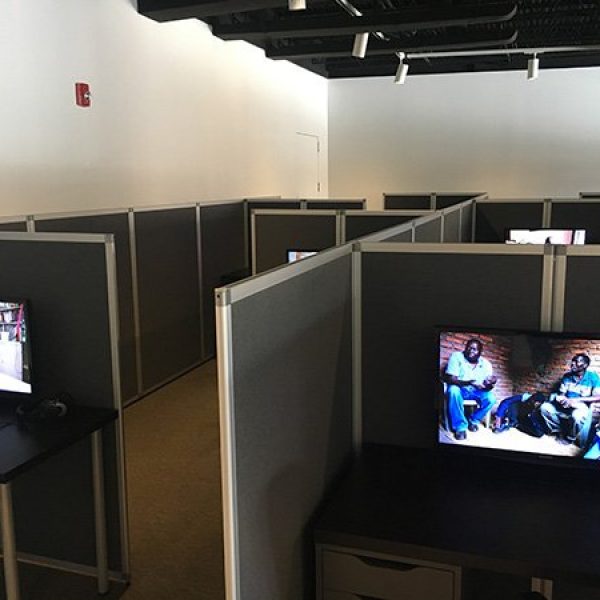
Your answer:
[359,242,559,256]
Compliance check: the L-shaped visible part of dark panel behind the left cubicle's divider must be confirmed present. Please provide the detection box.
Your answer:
[33,210,141,401]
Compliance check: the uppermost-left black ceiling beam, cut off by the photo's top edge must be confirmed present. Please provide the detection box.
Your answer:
[138,0,287,22]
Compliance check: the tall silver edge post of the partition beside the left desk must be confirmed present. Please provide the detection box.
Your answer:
[105,234,131,579]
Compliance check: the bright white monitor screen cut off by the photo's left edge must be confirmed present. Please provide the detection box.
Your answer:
[0,299,31,394]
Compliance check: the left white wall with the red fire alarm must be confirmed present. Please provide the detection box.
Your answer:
[0,0,327,215]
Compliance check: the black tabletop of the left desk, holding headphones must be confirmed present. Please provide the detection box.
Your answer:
[0,406,117,483]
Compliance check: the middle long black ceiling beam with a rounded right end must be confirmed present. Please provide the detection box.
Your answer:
[213,2,517,41]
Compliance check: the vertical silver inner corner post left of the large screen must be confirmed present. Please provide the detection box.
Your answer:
[352,243,363,455]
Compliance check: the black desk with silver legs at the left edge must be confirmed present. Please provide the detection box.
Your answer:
[0,406,117,600]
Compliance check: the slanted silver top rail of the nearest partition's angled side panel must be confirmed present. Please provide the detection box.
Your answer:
[215,242,355,306]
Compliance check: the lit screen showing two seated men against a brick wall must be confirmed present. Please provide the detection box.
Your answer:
[438,329,600,459]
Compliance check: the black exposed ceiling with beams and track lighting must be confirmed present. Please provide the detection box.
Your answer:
[138,0,600,78]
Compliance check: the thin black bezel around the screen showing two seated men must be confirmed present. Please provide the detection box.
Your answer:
[432,325,600,469]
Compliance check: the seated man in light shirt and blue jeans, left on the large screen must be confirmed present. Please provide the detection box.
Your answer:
[444,338,497,440]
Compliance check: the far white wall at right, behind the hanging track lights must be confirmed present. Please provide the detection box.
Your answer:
[329,67,600,208]
